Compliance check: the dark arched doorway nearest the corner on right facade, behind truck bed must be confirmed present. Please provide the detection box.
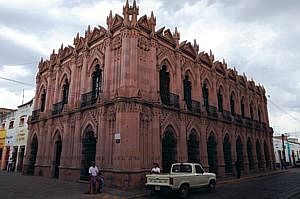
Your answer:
[162,127,177,173]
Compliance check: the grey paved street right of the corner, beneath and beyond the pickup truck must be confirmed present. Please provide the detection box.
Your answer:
[147,169,300,199]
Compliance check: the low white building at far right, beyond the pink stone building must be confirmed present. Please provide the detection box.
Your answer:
[273,136,300,167]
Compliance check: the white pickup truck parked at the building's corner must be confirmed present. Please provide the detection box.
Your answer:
[146,163,216,198]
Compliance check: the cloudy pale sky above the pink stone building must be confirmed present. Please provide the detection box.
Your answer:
[0,0,300,137]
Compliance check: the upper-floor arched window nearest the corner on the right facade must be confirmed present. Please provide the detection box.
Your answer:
[159,65,170,105]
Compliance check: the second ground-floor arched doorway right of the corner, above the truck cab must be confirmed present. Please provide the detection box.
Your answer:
[188,129,200,163]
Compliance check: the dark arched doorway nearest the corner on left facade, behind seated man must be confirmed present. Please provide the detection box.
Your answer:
[80,127,97,180]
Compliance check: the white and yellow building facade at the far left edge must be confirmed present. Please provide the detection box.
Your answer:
[0,100,33,171]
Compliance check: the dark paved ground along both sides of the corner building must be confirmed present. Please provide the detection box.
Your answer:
[0,169,300,199]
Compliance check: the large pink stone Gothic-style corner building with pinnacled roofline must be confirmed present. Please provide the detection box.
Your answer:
[24,1,274,189]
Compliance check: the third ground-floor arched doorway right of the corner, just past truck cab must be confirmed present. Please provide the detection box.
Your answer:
[207,132,218,174]
